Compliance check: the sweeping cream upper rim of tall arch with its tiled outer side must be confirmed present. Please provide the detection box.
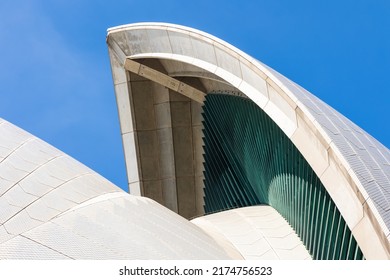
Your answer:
[107,23,390,258]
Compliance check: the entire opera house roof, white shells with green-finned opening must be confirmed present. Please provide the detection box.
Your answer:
[0,23,390,259]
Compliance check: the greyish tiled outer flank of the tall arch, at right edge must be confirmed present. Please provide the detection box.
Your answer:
[263,64,390,223]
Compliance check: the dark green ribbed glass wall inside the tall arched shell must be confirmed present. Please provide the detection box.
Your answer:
[203,94,364,259]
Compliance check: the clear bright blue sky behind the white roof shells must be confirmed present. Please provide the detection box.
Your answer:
[0,0,390,189]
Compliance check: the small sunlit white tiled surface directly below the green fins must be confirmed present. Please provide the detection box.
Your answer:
[191,205,312,260]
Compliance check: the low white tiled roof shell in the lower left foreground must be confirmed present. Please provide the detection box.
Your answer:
[0,119,235,259]
